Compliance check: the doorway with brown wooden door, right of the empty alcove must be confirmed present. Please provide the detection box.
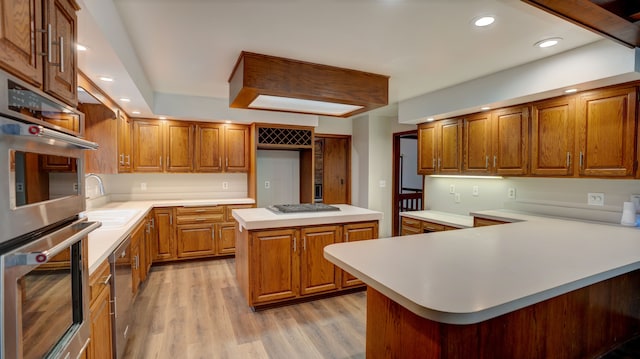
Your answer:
[314,134,351,204]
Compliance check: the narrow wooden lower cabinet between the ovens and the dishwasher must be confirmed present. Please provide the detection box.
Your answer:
[87,260,113,359]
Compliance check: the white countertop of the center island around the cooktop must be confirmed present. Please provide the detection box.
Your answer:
[232,204,382,230]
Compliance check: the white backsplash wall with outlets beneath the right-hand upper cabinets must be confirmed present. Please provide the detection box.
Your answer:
[425,176,640,223]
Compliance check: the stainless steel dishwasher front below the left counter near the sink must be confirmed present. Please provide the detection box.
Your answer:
[109,236,133,359]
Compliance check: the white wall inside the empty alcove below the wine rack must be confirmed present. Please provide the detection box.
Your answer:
[257,150,300,207]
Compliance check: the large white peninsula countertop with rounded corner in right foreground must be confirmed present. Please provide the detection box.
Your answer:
[325,211,640,324]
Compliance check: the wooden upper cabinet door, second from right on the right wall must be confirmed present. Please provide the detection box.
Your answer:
[531,96,576,176]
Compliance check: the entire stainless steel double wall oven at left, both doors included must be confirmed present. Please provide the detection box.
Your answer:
[0,72,100,359]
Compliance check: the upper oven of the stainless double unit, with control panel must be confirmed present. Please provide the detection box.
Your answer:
[0,77,98,248]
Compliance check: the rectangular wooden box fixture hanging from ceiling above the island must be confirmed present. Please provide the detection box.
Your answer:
[229,51,389,117]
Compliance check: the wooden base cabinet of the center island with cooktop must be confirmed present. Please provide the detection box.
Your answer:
[236,221,378,307]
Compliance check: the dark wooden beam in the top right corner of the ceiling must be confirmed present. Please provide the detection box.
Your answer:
[522,0,640,48]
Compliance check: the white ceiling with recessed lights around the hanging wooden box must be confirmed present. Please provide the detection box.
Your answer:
[78,0,601,120]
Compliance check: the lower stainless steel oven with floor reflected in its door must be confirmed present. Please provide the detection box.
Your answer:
[0,217,100,359]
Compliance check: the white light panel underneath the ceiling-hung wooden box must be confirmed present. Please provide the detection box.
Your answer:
[249,95,363,116]
